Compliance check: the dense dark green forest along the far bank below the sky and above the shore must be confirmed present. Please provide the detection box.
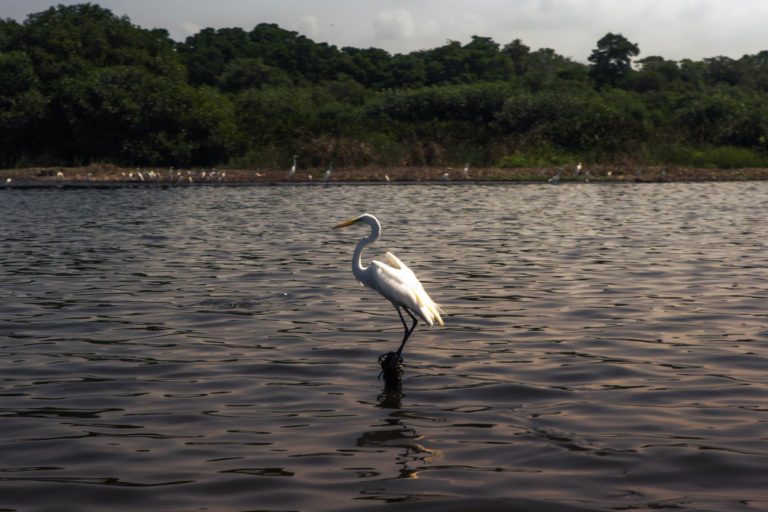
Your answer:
[0,3,768,167]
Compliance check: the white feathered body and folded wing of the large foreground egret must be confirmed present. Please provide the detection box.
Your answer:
[371,258,443,325]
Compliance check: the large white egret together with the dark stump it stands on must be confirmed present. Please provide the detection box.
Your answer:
[334,213,443,380]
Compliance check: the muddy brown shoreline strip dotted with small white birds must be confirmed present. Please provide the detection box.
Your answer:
[0,164,768,188]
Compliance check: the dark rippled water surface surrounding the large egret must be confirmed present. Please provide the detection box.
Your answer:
[0,183,768,511]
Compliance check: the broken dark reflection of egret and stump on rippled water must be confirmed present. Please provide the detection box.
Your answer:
[356,381,440,478]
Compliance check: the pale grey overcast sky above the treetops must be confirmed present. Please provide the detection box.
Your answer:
[0,0,768,62]
